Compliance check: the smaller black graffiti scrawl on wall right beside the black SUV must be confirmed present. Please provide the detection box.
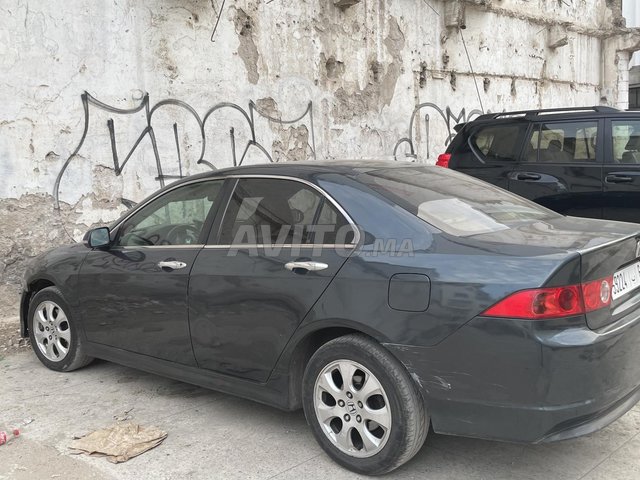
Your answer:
[393,102,484,160]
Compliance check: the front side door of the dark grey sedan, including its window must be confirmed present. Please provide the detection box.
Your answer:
[79,180,223,365]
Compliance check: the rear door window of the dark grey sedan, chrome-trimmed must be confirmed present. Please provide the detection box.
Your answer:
[219,178,354,245]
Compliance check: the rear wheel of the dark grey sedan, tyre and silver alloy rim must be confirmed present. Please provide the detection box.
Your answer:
[302,334,429,475]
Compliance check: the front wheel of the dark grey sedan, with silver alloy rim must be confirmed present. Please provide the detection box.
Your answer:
[27,287,93,372]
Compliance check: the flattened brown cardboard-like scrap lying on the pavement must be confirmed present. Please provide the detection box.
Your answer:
[69,423,167,463]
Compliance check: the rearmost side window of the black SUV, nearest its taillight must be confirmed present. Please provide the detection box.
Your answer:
[470,124,526,162]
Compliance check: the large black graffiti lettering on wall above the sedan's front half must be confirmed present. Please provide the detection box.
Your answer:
[53,92,316,208]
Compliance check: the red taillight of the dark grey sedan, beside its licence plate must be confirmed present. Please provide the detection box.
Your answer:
[482,277,612,320]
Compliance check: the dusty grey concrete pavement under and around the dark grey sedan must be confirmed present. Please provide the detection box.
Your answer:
[0,340,640,480]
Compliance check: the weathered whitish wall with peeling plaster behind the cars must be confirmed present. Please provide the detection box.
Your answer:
[0,0,632,304]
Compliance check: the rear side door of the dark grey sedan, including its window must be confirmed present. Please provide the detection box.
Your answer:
[189,177,358,382]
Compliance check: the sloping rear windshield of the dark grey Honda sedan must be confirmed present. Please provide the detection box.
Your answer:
[358,166,560,236]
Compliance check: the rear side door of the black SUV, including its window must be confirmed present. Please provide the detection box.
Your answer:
[508,119,603,218]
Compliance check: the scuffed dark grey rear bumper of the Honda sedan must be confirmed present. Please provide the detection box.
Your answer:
[387,313,640,443]
